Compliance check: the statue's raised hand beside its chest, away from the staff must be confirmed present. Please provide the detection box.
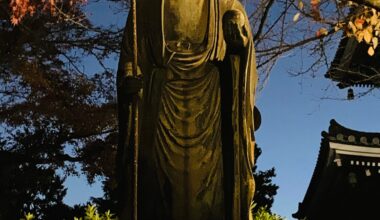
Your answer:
[223,10,248,51]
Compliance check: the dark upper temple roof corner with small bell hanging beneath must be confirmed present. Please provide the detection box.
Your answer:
[325,36,380,89]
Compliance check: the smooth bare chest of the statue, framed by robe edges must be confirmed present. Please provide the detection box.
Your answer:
[164,0,209,43]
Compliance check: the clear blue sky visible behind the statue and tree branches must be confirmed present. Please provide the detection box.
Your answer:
[65,1,380,219]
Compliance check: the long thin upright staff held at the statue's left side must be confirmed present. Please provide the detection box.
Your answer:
[132,0,142,220]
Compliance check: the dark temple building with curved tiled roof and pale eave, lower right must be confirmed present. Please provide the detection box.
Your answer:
[293,120,380,220]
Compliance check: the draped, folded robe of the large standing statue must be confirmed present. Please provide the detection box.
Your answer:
[117,0,257,220]
